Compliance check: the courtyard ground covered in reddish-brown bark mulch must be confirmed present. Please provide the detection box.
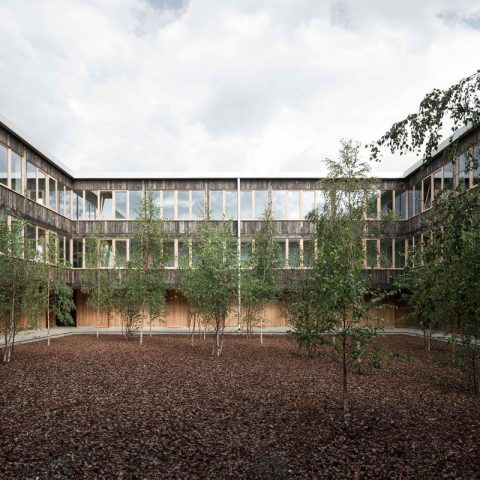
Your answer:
[0,335,480,479]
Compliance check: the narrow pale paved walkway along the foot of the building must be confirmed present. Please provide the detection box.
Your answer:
[7,327,456,344]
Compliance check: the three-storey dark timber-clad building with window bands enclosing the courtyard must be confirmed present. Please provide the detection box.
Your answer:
[0,118,480,326]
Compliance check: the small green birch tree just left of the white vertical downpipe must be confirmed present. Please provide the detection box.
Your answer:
[180,220,238,356]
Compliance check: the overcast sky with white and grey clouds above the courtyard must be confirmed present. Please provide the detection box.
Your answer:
[0,0,480,175]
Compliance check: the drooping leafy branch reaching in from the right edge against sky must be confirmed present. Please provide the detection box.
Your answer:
[368,70,480,161]
